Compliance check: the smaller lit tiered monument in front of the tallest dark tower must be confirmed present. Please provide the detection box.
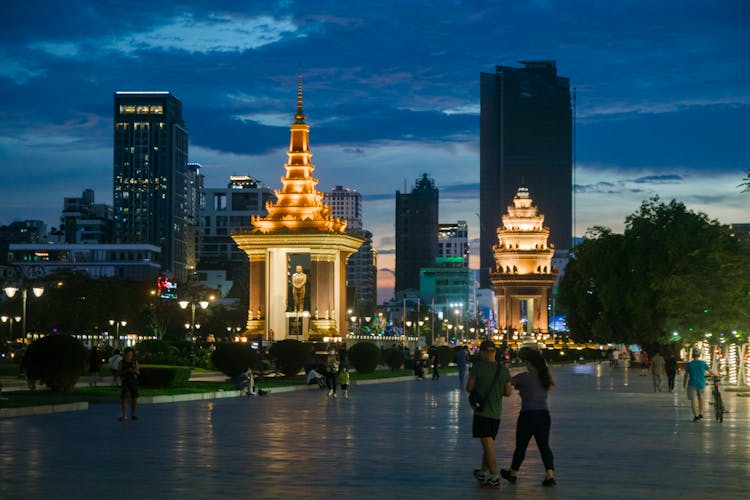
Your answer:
[490,187,557,334]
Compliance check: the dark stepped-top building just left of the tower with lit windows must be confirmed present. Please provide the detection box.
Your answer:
[60,189,112,243]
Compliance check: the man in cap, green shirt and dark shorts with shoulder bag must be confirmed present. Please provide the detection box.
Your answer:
[466,340,513,488]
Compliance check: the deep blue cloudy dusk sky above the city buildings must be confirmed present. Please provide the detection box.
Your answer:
[0,0,750,301]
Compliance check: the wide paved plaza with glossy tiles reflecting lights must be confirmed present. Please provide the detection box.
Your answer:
[0,364,750,499]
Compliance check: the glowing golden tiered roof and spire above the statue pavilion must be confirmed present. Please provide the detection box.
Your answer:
[250,78,347,233]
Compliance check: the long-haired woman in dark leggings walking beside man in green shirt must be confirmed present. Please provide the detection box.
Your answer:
[500,350,557,486]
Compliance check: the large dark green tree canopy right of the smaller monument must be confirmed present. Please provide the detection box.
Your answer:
[559,197,750,344]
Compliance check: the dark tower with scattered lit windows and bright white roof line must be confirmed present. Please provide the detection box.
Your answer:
[113,92,194,281]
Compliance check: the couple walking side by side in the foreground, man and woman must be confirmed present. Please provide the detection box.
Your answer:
[466,340,556,488]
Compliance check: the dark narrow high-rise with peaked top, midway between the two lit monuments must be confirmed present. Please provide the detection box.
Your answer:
[395,174,439,293]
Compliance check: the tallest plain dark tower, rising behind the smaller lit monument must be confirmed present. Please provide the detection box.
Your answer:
[479,61,573,288]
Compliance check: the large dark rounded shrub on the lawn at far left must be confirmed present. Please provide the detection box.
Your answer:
[24,335,86,392]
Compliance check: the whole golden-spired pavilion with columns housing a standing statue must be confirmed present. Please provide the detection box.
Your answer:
[232,77,364,340]
